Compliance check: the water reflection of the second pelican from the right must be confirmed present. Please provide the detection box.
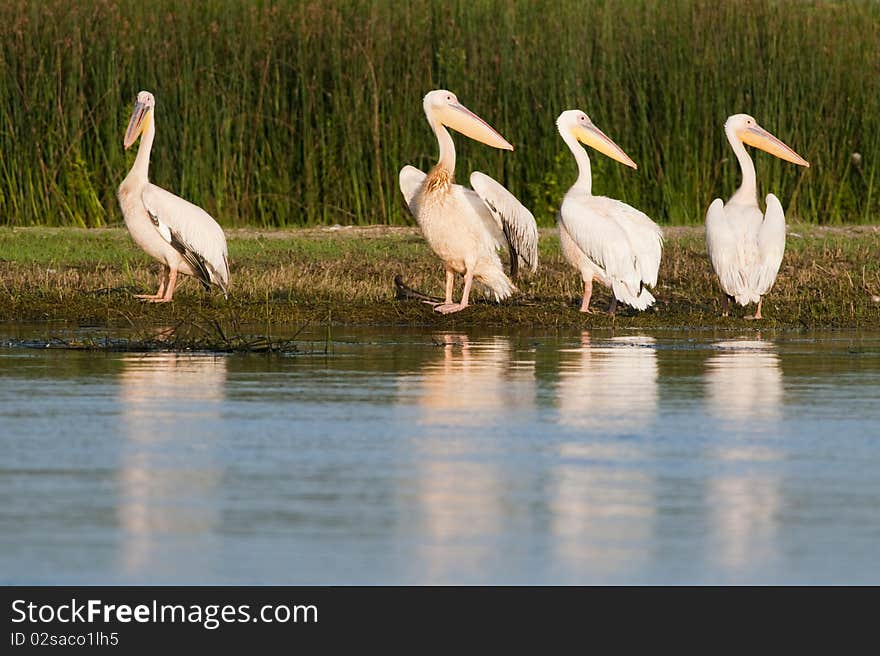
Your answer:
[550,332,658,581]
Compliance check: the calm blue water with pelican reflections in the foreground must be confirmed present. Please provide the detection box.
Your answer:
[0,326,880,584]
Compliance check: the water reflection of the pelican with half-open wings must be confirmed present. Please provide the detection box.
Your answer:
[400,334,535,583]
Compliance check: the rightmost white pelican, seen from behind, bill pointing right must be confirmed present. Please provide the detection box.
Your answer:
[706,114,810,319]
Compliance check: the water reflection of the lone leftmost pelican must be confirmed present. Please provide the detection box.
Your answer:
[117,353,226,580]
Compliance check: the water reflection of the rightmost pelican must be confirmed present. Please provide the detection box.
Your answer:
[706,340,783,582]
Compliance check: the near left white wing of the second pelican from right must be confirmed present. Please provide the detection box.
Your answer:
[559,195,654,310]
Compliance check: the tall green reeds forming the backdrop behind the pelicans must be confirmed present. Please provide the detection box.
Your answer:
[0,0,880,226]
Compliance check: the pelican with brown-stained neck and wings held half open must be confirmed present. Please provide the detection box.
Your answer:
[400,90,538,314]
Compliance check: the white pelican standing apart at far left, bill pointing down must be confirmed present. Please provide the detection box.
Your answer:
[118,91,229,303]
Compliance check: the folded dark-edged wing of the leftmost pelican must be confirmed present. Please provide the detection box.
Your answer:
[141,183,229,294]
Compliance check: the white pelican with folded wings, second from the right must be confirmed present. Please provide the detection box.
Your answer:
[556,109,663,314]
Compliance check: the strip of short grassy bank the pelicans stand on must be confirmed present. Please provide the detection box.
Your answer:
[0,224,880,335]
